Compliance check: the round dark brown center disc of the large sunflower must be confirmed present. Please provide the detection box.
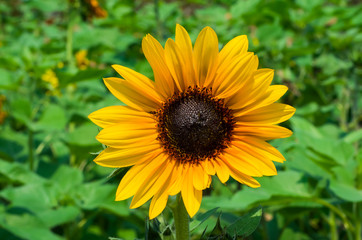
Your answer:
[155,87,234,162]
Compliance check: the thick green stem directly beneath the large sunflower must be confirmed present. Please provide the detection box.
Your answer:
[172,193,190,240]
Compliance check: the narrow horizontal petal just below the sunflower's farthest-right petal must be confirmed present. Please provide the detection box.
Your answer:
[233,124,293,140]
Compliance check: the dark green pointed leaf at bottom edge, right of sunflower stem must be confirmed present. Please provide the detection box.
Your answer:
[226,207,263,237]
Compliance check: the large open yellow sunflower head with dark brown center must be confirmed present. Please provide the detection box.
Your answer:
[89,25,295,219]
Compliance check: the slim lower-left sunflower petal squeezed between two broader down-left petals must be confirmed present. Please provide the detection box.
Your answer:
[130,158,175,208]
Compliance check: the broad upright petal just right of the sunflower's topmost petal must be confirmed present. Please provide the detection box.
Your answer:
[194,27,219,87]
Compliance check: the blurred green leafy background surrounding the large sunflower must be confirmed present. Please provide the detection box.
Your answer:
[0,0,362,240]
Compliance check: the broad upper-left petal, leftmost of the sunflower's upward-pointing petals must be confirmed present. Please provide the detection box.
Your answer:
[142,34,175,100]
